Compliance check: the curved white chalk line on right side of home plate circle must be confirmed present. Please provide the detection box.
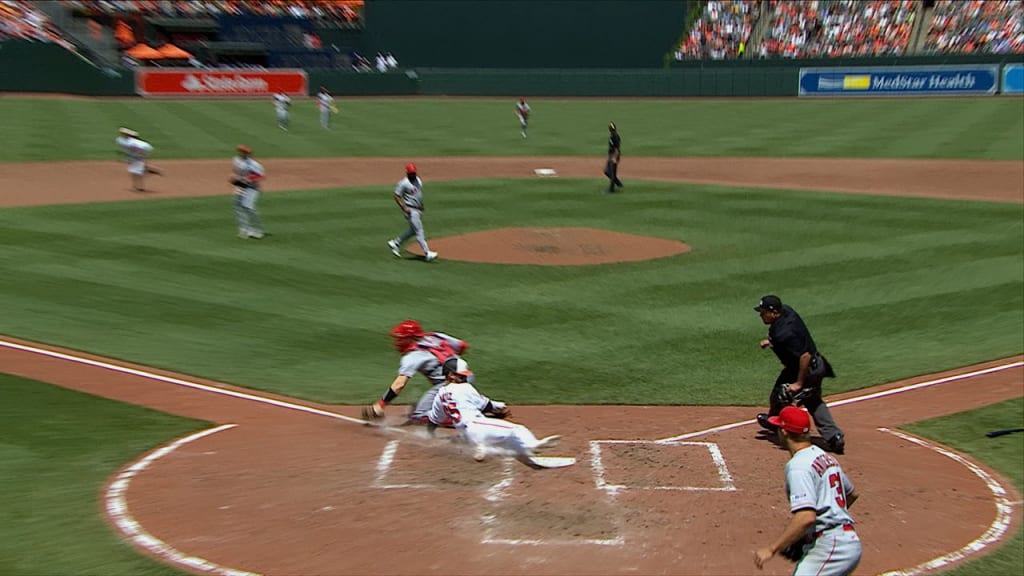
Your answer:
[879,428,1013,576]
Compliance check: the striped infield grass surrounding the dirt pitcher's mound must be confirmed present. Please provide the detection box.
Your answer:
[0,179,1024,405]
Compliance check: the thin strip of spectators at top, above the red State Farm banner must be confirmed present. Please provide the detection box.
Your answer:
[70,0,365,24]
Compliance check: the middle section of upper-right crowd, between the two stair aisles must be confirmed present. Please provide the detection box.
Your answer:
[763,0,916,58]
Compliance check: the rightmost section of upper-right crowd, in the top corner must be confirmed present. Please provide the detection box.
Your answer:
[924,0,1024,54]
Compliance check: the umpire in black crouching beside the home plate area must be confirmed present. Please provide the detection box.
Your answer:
[754,295,846,454]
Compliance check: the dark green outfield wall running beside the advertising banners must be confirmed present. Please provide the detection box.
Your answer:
[0,41,1024,97]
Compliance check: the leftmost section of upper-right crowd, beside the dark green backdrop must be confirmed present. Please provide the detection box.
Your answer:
[675,0,761,60]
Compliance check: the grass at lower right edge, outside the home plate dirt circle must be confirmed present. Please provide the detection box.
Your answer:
[909,399,1024,576]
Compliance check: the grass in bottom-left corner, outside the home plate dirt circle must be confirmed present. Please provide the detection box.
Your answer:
[0,373,201,576]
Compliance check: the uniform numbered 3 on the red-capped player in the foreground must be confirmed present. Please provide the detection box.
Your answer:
[785,445,861,576]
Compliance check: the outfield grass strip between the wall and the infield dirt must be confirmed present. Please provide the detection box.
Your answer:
[0,97,1024,162]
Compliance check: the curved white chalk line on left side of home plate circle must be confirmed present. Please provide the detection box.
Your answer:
[103,424,258,576]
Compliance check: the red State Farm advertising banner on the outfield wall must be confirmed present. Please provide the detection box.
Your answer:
[135,68,307,98]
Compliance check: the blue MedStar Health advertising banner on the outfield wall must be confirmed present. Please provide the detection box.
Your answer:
[800,65,999,96]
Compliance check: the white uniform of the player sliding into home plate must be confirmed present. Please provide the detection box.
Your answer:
[428,382,540,456]
